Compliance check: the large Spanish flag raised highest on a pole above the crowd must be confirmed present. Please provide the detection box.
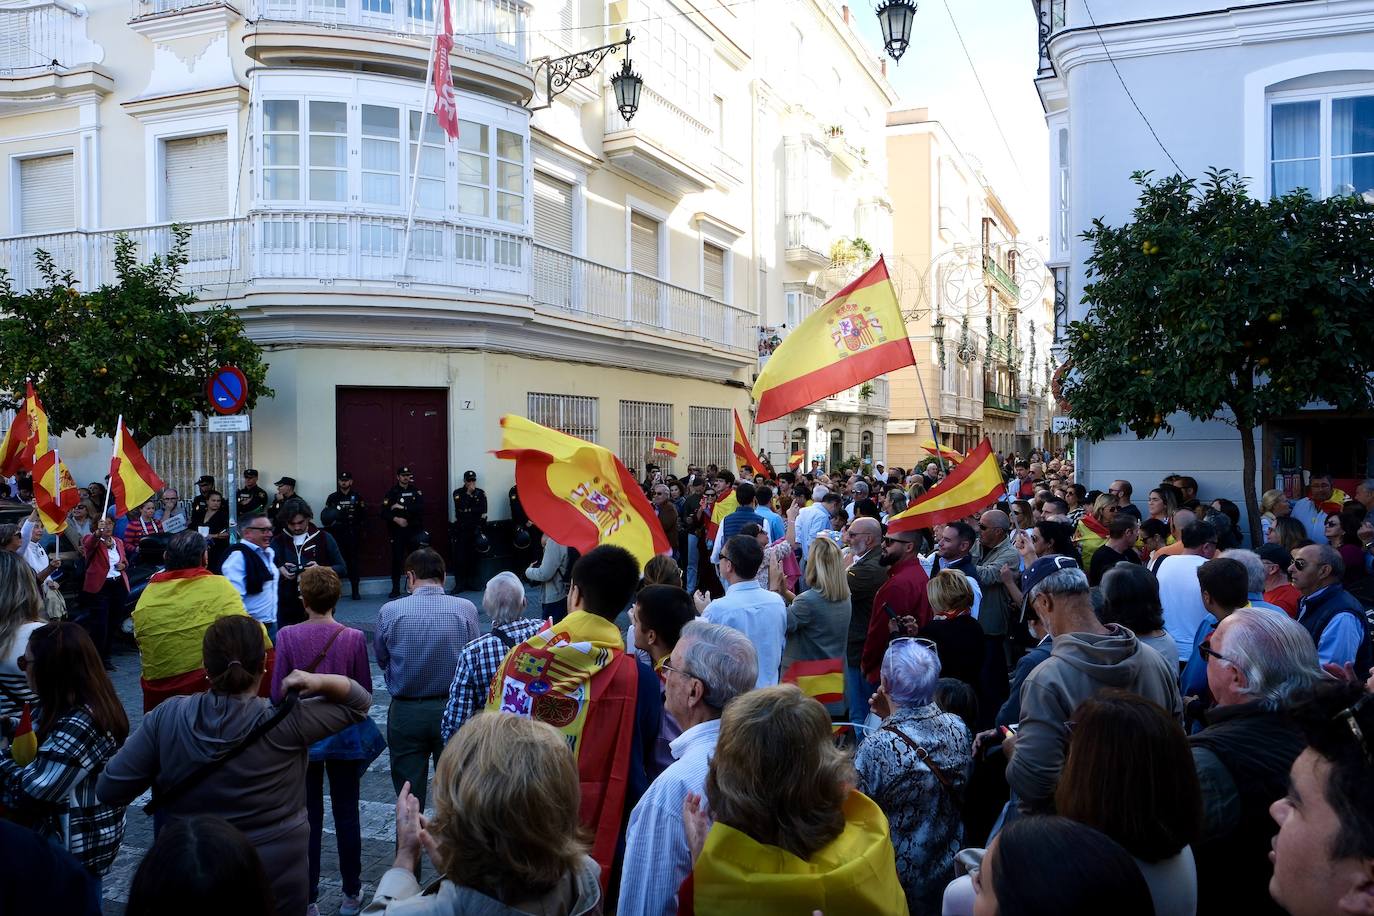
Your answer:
[754,258,916,423]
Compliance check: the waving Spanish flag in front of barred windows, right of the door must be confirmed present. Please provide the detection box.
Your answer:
[496,415,672,566]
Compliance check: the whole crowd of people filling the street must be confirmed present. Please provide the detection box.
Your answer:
[0,455,1374,916]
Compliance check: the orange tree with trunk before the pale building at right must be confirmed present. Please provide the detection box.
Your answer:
[1062,170,1374,544]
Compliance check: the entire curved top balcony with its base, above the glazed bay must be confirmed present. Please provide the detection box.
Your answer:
[243,0,534,104]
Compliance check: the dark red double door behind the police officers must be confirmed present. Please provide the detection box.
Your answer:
[334,387,452,575]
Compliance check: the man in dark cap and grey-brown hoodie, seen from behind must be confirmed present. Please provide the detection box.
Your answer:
[1003,556,1183,813]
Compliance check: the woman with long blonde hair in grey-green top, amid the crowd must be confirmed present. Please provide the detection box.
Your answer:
[775,537,851,718]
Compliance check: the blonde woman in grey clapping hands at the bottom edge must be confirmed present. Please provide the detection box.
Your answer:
[364,713,600,916]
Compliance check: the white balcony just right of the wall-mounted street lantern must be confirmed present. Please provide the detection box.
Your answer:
[602,81,720,198]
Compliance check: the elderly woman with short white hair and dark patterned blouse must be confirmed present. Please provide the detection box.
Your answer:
[855,637,973,913]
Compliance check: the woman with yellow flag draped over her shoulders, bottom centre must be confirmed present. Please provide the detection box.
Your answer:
[677,683,912,916]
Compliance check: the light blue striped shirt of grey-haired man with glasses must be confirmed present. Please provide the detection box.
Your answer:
[620,718,720,916]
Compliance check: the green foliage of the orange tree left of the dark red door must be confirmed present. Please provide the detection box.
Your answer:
[0,227,272,442]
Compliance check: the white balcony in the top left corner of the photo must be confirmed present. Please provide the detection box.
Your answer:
[0,0,114,114]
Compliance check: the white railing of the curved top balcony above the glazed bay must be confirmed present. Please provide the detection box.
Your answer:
[247,0,529,63]
